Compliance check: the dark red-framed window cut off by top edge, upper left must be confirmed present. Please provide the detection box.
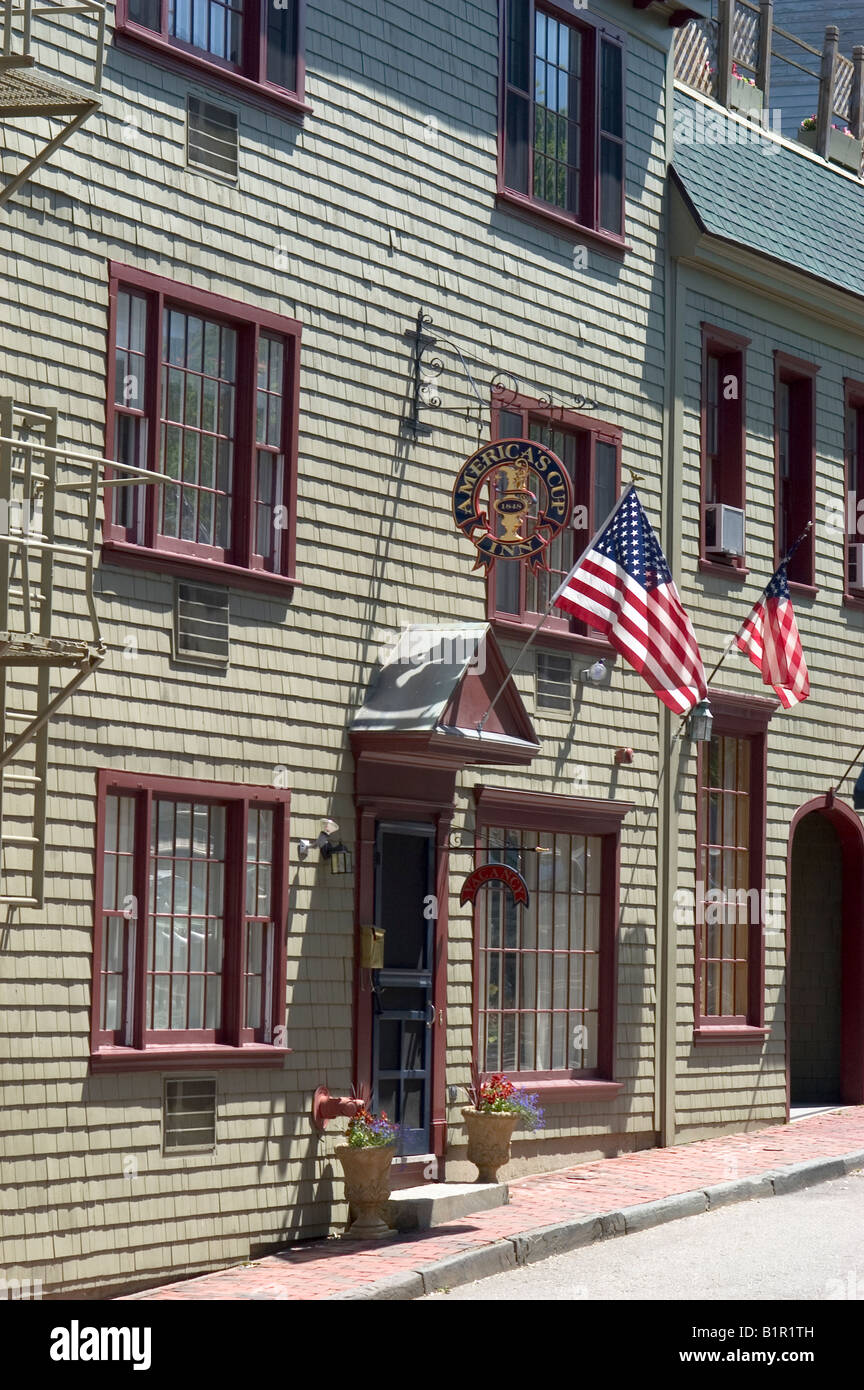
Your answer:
[117,0,304,103]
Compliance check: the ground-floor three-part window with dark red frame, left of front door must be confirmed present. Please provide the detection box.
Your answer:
[93,773,289,1055]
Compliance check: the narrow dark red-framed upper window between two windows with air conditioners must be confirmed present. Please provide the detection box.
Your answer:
[774,353,818,585]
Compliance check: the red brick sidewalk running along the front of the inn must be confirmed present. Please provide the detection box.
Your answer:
[126,1106,864,1300]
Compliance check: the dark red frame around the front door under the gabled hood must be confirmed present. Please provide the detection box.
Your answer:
[354,798,453,1182]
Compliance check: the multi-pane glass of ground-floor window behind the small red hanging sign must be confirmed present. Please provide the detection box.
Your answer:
[478,826,610,1073]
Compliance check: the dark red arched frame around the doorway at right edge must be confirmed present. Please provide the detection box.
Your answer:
[785,791,864,1120]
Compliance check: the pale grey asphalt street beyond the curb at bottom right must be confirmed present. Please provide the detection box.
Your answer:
[417,1172,864,1302]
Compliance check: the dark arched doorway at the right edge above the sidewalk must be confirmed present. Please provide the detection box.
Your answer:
[786,794,864,1105]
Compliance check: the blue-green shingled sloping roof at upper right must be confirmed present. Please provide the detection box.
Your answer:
[672,92,864,296]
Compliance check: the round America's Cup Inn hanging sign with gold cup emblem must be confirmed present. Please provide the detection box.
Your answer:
[453,439,572,573]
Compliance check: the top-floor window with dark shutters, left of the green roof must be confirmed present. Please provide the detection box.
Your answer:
[500,0,625,238]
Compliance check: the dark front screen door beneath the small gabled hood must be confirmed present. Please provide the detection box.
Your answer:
[372,821,435,1154]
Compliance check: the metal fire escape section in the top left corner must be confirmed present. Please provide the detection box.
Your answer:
[0,0,106,206]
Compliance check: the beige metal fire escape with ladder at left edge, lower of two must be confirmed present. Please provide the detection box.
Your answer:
[0,398,165,908]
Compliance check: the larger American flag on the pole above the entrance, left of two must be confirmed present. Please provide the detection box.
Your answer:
[553,487,707,714]
